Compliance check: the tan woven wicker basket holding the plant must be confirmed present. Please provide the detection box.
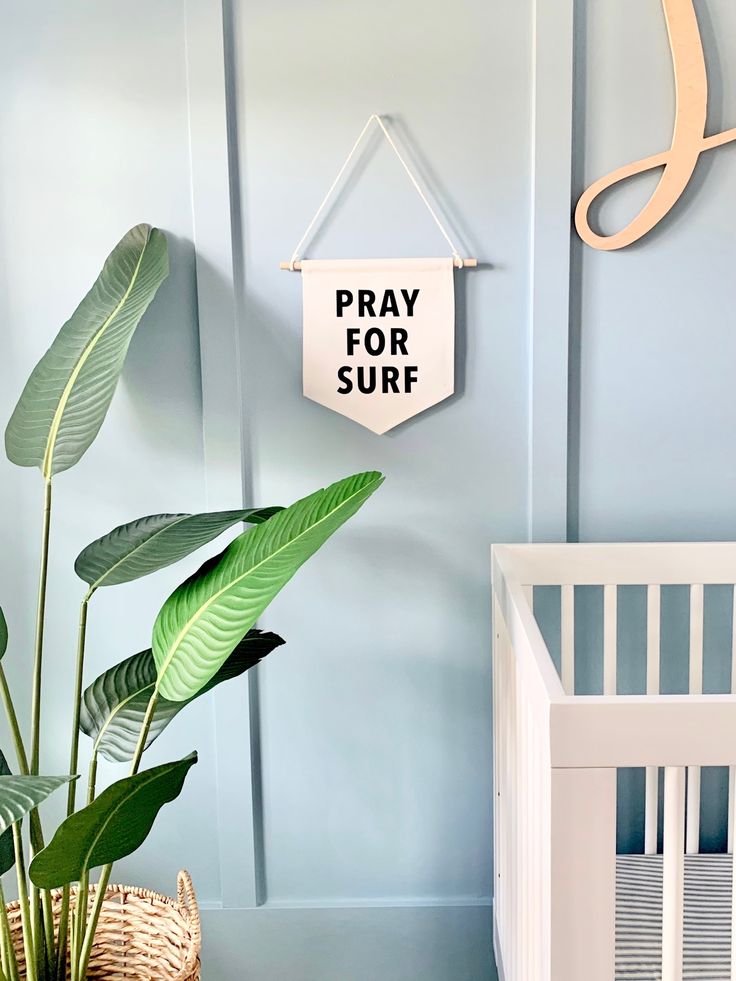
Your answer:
[7,872,202,981]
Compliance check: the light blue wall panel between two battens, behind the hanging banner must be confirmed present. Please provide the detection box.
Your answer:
[234,0,530,905]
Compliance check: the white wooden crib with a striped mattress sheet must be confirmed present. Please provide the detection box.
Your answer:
[493,543,736,981]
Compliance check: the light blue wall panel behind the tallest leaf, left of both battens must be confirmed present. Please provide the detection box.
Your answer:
[0,0,221,903]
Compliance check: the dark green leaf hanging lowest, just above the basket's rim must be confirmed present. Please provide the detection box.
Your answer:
[29,753,197,889]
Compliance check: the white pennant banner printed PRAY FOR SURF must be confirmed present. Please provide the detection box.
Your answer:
[302,258,455,433]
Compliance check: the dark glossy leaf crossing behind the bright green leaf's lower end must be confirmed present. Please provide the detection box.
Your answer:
[79,630,284,763]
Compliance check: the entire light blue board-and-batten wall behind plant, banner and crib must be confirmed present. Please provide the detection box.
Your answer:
[0,0,736,981]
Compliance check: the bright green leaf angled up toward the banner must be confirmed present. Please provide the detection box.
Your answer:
[153,472,383,702]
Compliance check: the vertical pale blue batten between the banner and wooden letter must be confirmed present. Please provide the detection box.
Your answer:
[528,0,575,542]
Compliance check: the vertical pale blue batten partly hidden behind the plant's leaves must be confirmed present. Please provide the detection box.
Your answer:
[186,0,263,907]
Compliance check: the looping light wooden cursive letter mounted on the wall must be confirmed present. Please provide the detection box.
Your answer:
[575,0,736,251]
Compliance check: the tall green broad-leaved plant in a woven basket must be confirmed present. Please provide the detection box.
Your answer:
[0,225,383,981]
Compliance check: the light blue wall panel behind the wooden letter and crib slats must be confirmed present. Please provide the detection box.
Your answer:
[569,0,736,849]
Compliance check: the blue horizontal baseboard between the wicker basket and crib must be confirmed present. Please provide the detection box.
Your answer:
[202,906,497,981]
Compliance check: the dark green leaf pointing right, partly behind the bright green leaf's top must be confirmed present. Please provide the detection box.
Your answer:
[74,508,281,589]
